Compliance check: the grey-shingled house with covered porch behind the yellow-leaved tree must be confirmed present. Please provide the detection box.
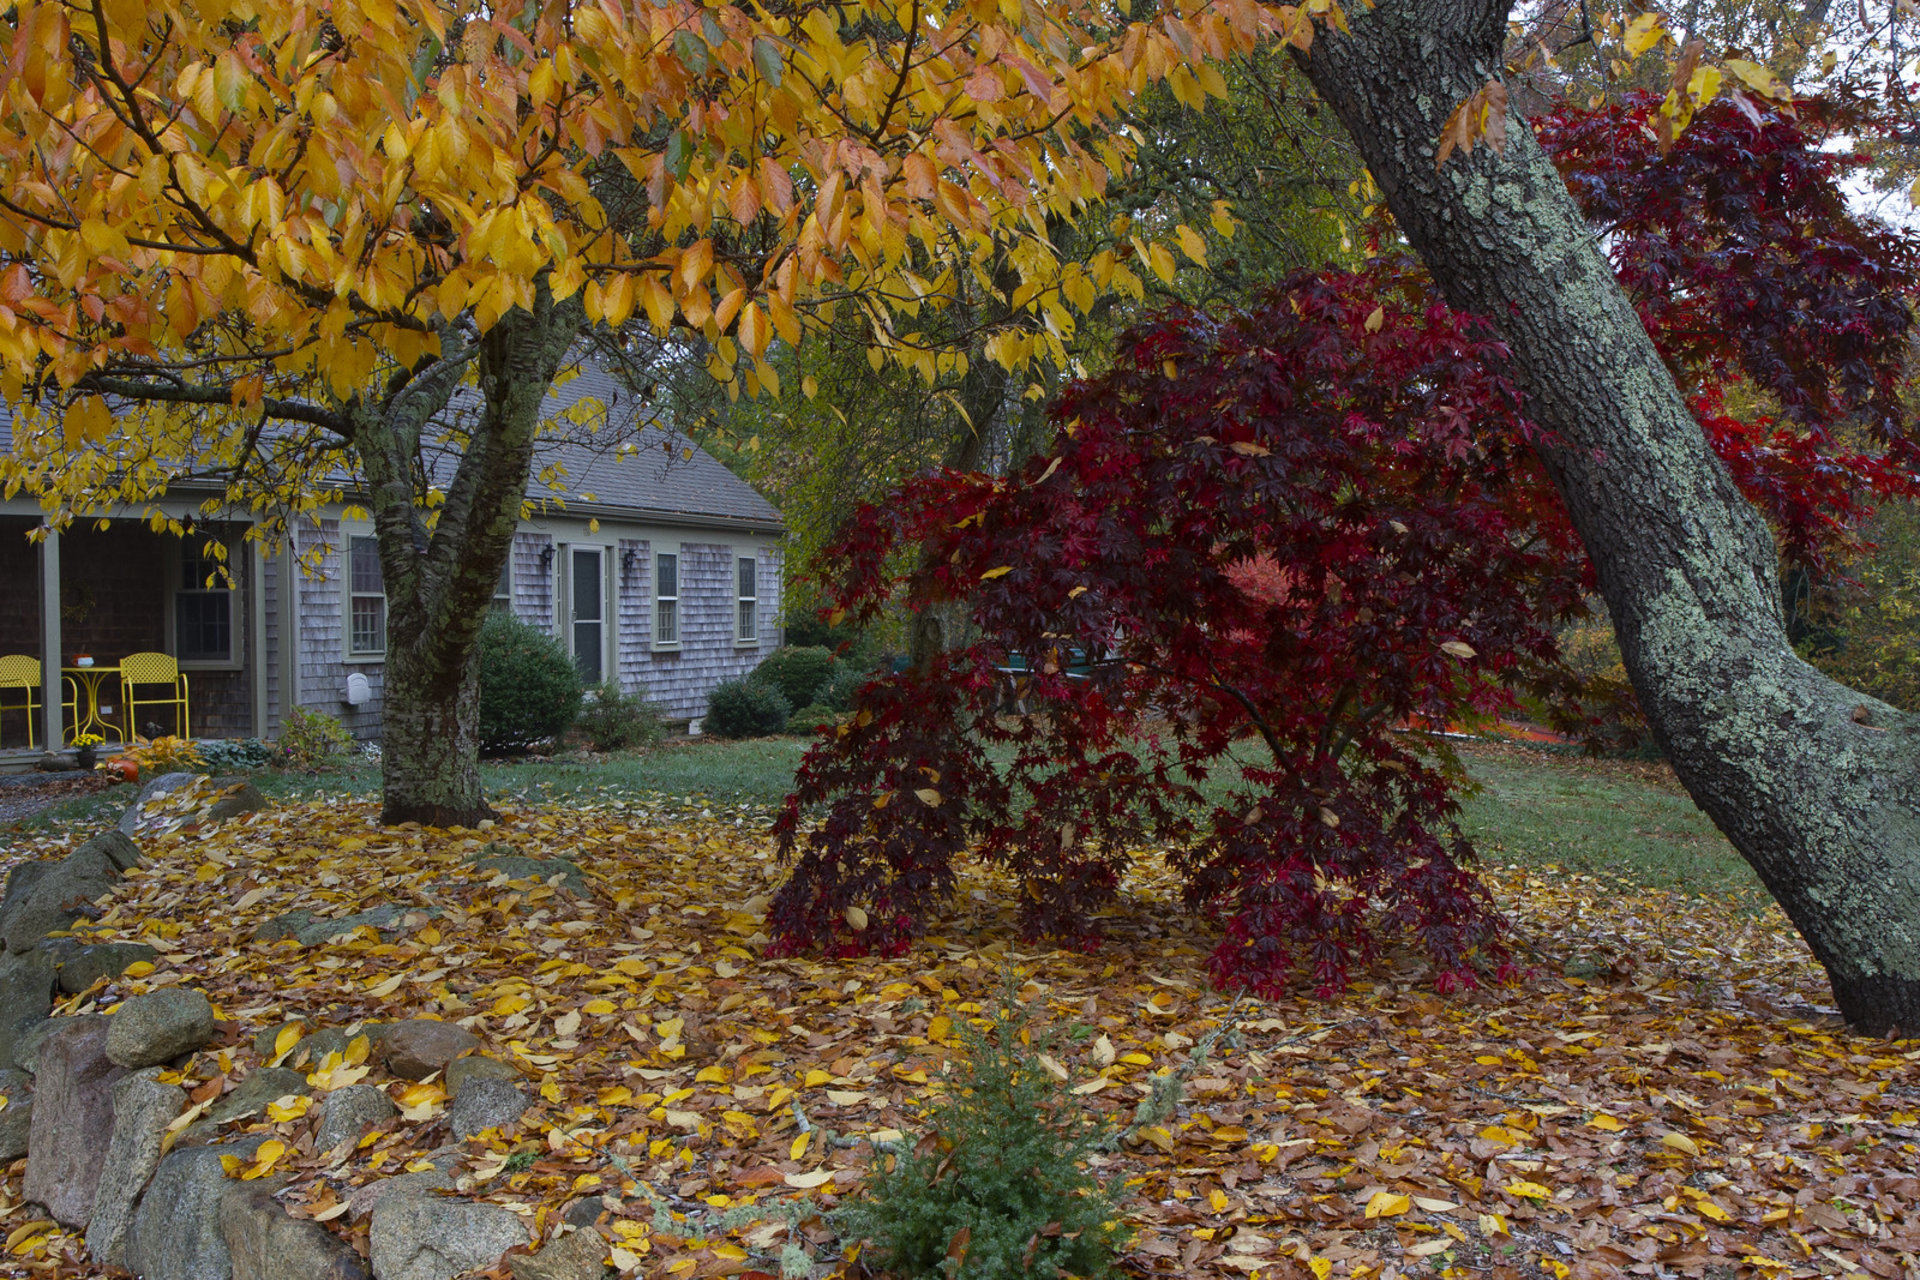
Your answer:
[0,365,783,762]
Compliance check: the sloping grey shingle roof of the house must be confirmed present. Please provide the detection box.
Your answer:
[0,361,781,530]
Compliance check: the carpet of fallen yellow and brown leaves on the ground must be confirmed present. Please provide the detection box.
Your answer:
[0,798,1920,1280]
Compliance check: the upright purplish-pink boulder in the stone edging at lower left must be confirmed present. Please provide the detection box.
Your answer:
[21,1017,127,1226]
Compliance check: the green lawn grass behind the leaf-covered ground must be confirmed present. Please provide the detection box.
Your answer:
[0,737,1766,906]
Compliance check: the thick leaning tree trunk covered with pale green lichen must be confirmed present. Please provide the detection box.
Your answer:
[1300,0,1920,1034]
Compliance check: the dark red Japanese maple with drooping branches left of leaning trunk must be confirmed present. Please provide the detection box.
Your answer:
[772,274,1584,990]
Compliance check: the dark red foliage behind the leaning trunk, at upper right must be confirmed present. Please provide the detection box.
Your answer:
[1536,94,1920,570]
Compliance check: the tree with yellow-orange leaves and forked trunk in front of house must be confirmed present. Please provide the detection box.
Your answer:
[0,0,1267,823]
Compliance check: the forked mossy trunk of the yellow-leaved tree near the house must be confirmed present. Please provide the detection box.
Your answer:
[353,286,584,827]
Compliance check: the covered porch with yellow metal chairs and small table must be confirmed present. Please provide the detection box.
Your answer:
[0,514,265,768]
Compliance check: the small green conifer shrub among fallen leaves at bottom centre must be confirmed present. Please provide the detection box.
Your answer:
[831,990,1127,1280]
